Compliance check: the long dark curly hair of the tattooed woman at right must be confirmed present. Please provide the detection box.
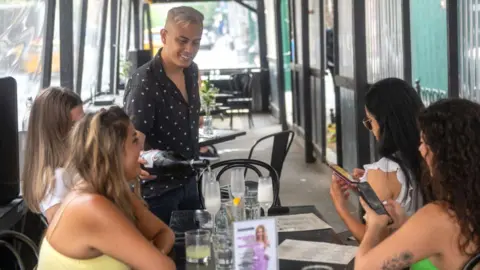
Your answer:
[419,99,480,255]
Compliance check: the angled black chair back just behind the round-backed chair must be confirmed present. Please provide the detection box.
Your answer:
[245,130,295,179]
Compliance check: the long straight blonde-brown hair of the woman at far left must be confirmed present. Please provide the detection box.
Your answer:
[22,87,82,213]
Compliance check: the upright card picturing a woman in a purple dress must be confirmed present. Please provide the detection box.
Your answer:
[233,218,278,270]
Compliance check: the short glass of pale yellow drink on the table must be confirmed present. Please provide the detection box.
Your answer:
[185,230,211,264]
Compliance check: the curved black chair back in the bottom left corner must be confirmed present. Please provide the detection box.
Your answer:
[0,230,38,270]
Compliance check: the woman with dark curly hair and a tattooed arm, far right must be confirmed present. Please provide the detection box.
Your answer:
[355,99,480,270]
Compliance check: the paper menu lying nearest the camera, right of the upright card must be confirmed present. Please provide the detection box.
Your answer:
[278,239,358,265]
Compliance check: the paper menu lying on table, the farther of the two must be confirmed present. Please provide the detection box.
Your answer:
[275,213,332,232]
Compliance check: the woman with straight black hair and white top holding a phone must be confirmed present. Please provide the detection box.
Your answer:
[330,78,424,242]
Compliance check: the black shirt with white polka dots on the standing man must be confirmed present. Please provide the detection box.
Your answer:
[124,51,200,185]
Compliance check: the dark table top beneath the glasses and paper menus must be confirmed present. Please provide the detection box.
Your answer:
[170,205,353,270]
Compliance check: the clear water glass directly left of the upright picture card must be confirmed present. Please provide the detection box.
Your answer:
[212,234,233,270]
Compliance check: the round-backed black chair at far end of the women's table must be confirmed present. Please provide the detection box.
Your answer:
[198,159,281,208]
